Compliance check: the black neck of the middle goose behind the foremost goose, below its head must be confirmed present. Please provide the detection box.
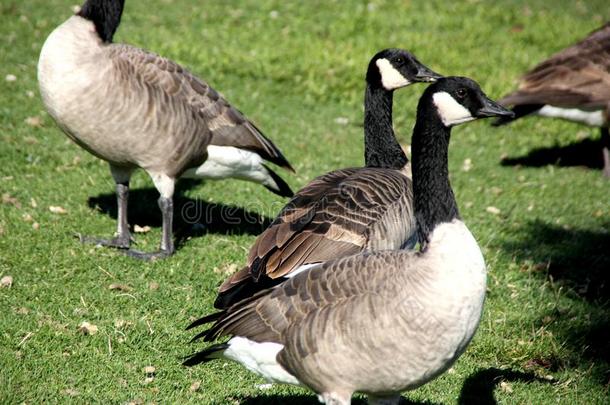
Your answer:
[364,84,409,169]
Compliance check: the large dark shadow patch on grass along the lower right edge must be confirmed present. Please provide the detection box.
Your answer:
[503,221,610,376]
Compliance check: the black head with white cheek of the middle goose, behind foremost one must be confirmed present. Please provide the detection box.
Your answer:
[366,48,443,91]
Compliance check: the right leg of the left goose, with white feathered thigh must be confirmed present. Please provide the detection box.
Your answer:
[125,175,175,260]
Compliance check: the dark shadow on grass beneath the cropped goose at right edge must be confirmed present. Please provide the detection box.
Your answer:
[500,139,604,169]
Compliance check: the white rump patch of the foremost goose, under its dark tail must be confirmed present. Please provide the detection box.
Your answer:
[224,336,302,385]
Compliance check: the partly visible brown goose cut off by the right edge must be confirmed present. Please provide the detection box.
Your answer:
[494,23,610,177]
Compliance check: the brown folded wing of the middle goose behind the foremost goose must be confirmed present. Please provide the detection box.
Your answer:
[220,168,411,300]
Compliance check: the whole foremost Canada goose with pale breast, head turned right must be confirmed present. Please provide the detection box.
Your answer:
[184,77,512,405]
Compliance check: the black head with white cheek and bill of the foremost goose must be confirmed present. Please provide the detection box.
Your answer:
[425,76,515,127]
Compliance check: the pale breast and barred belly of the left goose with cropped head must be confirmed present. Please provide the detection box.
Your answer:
[38,16,209,176]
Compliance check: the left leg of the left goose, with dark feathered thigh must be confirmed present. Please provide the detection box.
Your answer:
[78,166,131,249]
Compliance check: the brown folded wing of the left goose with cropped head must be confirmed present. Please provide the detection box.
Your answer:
[111,45,294,171]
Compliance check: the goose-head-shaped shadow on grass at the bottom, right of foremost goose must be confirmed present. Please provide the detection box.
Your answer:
[458,367,550,405]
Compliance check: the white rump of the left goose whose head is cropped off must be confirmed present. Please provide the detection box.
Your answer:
[182,145,278,189]
